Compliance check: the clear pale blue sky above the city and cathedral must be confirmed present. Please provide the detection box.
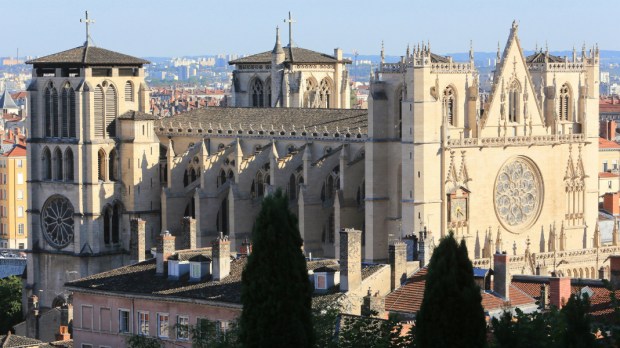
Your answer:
[6,0,620,57]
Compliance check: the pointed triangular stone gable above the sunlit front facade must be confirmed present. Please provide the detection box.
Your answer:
[481,22,546,137]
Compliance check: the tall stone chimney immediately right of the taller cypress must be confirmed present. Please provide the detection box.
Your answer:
[340,228,362,292]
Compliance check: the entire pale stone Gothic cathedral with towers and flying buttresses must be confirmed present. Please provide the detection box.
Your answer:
[25,20,599,306]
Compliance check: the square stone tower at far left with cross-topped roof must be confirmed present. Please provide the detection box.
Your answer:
[24,13,160,307]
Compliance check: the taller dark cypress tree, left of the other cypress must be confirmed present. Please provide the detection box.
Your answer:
[239,190,314,347]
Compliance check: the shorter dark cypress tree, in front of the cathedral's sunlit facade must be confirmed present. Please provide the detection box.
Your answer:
[416,232,487,348]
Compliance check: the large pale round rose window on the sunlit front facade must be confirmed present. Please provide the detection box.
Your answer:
[495,158,542,229]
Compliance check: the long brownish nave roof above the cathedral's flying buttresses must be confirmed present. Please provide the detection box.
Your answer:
[155,107,368,134]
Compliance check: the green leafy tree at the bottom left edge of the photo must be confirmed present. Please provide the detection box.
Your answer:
[0,276,22,334]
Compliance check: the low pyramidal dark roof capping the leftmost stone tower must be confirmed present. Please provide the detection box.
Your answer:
[26,46,150,66]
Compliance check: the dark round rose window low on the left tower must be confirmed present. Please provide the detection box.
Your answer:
[41,196,74,249]
